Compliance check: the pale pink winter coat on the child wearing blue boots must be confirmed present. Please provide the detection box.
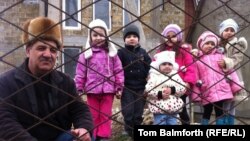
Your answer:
[192,52,233,105]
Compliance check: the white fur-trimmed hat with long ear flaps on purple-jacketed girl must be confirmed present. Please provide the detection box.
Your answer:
[83,19,117,59]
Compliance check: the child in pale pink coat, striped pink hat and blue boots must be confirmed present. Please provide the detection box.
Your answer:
[194,31,241,125]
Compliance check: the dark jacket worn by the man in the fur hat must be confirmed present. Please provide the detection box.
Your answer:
[0,59,93,141]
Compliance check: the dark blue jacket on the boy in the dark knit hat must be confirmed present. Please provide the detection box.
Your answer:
[118,45,151,90]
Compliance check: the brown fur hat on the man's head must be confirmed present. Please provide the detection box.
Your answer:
[22,17,62,49]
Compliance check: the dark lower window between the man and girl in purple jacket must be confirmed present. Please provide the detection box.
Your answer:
[62,47,81,78]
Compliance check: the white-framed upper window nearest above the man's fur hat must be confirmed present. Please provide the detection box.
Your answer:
[62,0,81,30]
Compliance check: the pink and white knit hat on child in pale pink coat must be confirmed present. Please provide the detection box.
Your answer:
[197,31,219,49]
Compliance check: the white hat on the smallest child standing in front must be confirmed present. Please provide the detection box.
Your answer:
[151,51,179,71]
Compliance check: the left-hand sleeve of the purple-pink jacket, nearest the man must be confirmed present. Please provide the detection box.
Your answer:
[74,53,87,91]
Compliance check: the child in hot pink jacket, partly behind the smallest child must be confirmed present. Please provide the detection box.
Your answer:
[158,24,196,125]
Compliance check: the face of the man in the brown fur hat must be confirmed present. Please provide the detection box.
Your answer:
[26,41,57,76]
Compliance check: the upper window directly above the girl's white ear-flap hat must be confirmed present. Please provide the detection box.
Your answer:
[93,0,111,30]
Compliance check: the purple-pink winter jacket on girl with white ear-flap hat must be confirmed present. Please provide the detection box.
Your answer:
[75,48,124,94]
